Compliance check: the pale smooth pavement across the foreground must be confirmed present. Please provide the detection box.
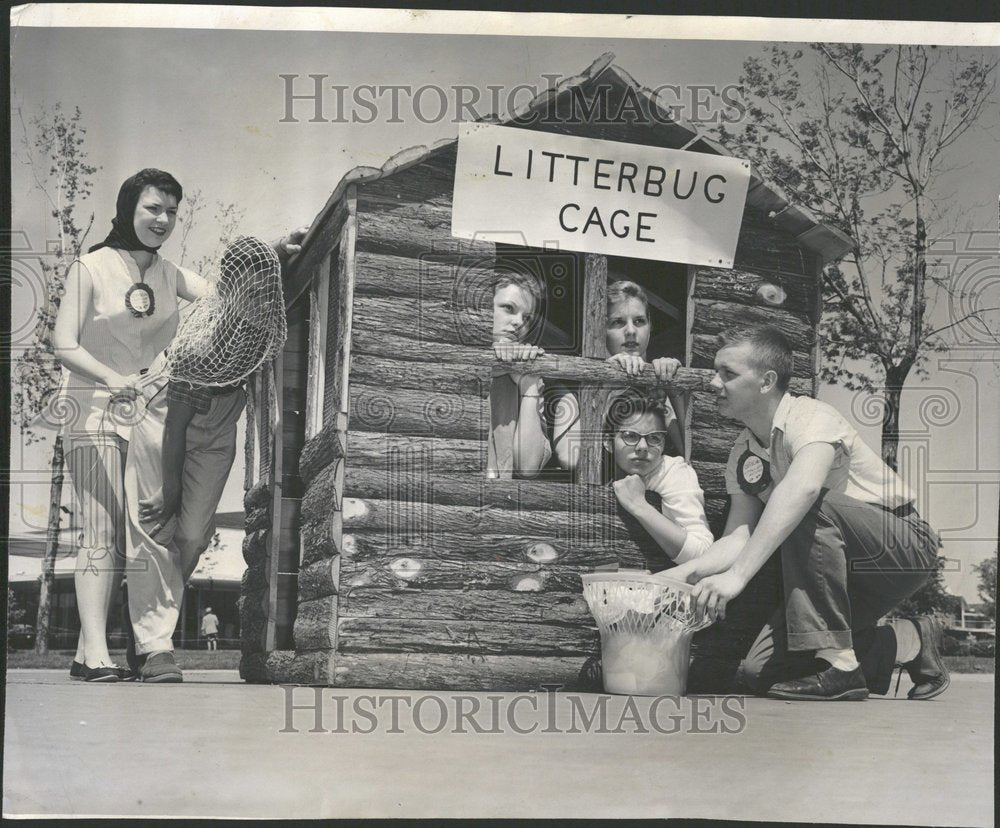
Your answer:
[3,670,994,826]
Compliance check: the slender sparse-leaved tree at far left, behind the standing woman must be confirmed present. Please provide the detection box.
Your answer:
[11,103,99,653]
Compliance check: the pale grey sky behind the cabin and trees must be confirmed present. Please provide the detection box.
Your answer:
[11,10,1000,601]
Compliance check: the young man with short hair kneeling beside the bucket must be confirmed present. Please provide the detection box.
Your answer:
[671,325,949,701]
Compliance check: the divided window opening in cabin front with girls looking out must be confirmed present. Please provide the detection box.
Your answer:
[487,245,690,483]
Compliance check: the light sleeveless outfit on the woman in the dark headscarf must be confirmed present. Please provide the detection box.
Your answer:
[56,247,178,451]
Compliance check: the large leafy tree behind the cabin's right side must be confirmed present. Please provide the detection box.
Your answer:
[719,43,1000,469]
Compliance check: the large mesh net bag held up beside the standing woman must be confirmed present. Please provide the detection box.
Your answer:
[168,236,287,386]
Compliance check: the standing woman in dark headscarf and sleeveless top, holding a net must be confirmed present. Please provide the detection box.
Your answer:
[52,169,206,682]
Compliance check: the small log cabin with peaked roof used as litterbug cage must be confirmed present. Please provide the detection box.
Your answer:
[240,50,851,692]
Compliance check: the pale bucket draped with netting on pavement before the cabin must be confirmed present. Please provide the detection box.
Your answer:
[583,572,711,696]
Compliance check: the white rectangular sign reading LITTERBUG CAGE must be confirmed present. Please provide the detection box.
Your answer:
[451,124,750,267]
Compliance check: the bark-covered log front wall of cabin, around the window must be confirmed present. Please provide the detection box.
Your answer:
[268,142,817,692]
